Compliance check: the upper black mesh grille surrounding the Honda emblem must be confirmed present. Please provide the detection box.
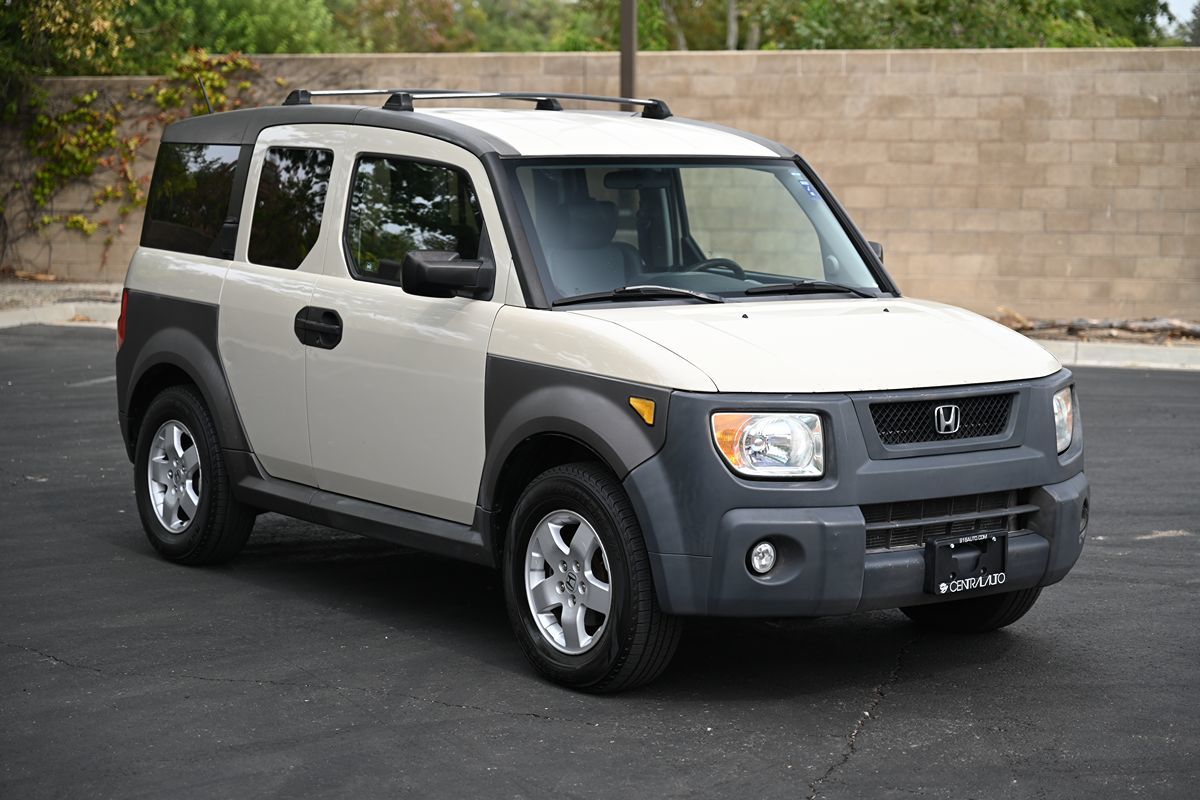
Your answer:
[871,392,1016,445]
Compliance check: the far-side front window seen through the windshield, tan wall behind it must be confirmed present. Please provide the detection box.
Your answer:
[679,167,826,279]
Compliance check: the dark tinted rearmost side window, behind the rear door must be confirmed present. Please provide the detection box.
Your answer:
[142,143,241,258]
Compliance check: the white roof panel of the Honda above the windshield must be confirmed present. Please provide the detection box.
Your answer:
[414,108,779,158]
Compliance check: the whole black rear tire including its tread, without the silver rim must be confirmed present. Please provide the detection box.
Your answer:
[133,385,254,565]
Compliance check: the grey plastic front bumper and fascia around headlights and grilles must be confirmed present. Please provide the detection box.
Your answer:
[625,371,1088,616]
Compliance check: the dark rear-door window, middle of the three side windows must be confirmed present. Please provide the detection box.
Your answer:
[247,148,334,270]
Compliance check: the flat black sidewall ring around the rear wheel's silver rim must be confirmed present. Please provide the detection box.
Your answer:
[133,389,215,559]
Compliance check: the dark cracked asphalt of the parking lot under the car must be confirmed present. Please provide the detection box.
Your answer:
[0,327,1200,800]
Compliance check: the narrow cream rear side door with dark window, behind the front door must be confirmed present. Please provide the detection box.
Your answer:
[218,126,335,486]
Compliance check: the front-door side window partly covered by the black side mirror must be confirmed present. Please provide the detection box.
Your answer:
[346,156,482,283]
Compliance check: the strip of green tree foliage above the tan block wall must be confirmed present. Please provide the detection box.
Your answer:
[0,0,1180,85]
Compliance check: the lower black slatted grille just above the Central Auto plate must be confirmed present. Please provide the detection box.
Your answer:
[862,489,1038,551]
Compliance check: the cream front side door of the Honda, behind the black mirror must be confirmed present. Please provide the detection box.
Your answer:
[307,127,511,523]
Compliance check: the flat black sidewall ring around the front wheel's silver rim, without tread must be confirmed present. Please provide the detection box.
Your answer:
[504,474,635,687]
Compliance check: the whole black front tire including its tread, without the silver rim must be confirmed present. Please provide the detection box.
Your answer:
[502,463,682,693]
